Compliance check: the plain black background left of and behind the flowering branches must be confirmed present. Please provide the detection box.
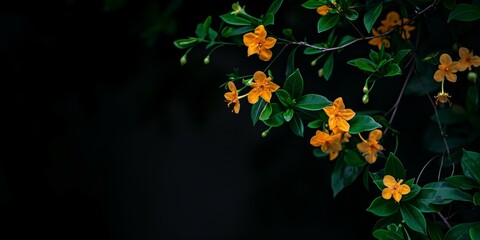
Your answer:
[0,0,468,240]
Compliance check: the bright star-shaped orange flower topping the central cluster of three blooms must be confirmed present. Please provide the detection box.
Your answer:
[323,97,355,132]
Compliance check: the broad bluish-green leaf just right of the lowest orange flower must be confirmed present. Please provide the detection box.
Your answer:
[417,181,473,204]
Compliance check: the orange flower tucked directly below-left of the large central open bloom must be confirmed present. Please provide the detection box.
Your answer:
[310,130,342,161]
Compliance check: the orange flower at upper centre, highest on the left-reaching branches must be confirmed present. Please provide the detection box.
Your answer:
[243,25,277,61]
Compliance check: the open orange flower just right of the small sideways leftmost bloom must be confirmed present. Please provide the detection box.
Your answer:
[248,71,280,104]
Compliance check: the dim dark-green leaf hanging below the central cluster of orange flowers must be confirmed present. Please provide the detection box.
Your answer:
[331,159,363,197]
